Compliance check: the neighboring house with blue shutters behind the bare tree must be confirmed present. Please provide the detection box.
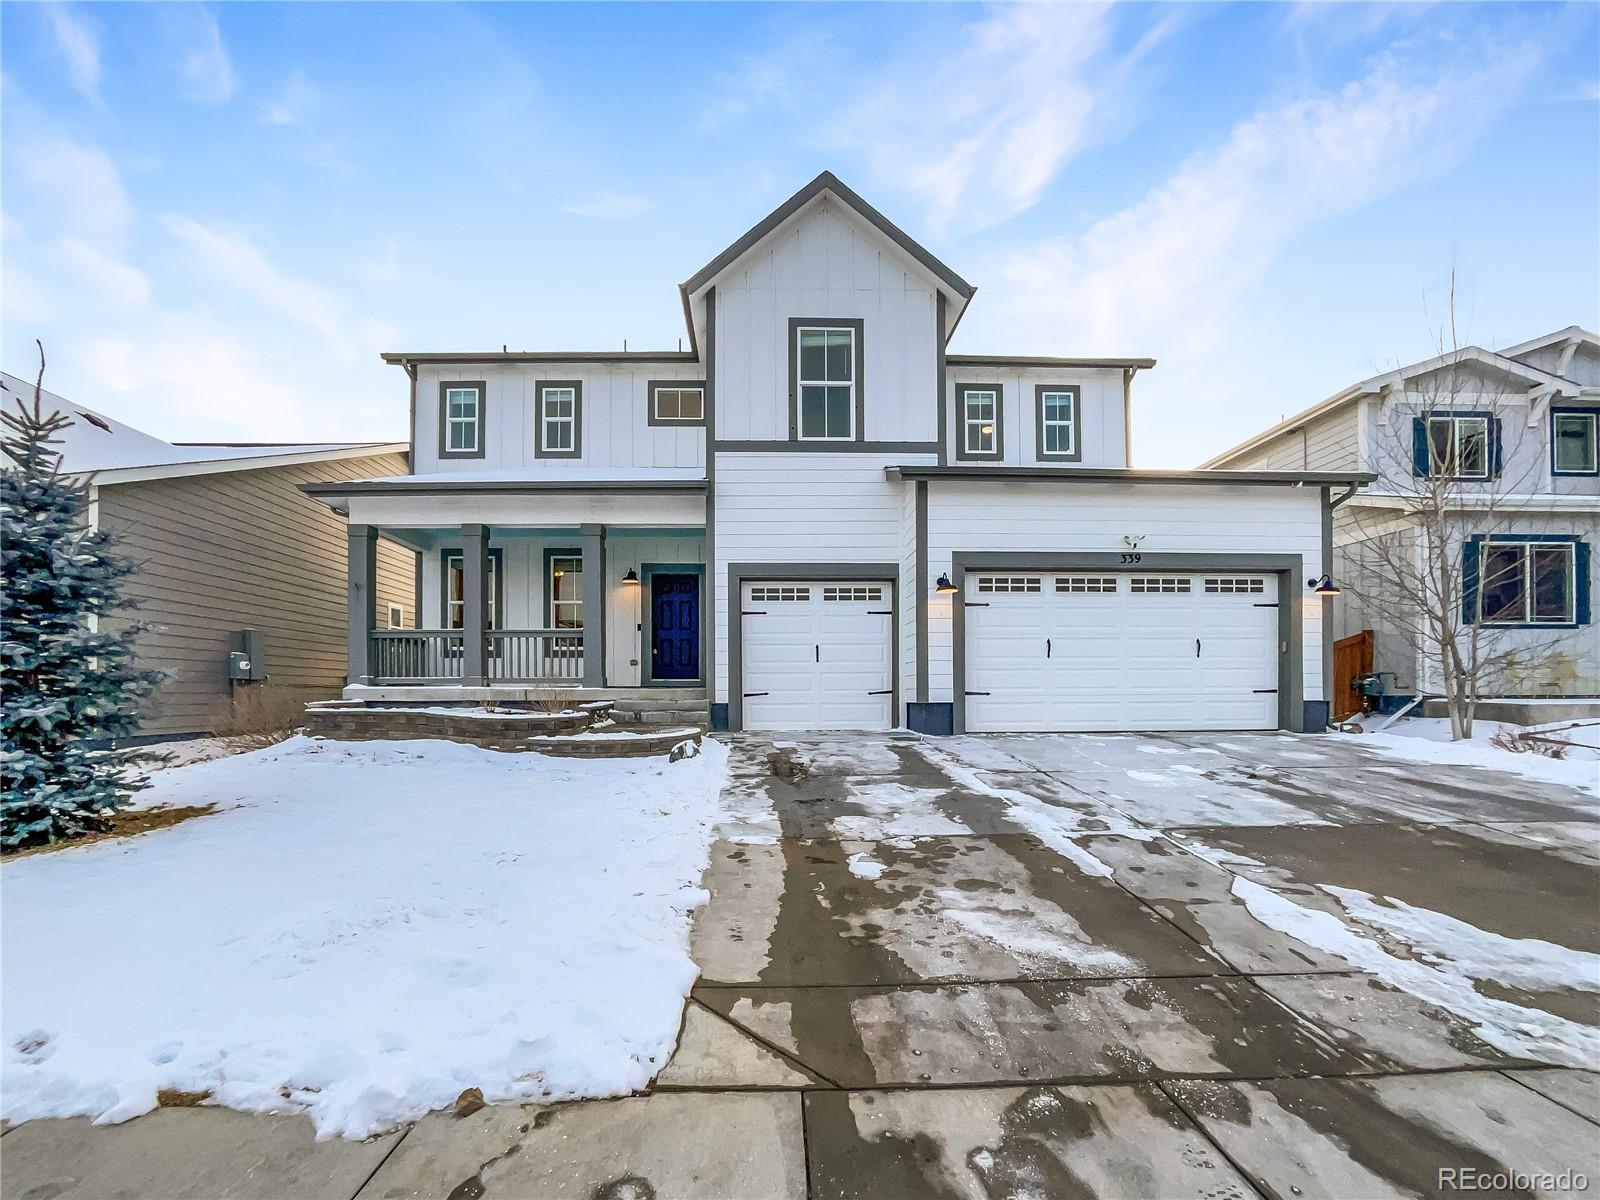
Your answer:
[1205,325,1600,696]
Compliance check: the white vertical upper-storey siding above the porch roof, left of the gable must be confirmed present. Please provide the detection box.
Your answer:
[414,362,706,475]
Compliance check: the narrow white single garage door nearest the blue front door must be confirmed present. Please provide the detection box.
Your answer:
[739,581,894,730]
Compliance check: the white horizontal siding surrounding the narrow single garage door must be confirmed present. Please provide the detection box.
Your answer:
[712,454,933,710]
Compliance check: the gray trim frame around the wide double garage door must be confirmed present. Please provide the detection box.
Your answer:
[950,550,1306,733]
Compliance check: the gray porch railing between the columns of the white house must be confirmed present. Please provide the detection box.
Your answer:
[371,629,584,685]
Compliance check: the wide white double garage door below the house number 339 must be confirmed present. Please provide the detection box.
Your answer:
[966,571,1278,733]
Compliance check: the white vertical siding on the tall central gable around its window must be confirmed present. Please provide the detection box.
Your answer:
[717,197,938,442]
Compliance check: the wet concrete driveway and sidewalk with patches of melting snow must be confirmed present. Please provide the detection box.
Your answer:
[0,734,1600,1200]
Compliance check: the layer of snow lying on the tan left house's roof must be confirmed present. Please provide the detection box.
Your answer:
[0,371,400,474]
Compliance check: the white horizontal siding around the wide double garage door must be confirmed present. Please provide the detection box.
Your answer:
[921,482,1323,702]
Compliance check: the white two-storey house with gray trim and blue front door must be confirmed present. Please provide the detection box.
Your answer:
[306,173,1360,731]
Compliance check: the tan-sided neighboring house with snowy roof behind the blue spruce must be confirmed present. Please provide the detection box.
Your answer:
[0,373,416,738]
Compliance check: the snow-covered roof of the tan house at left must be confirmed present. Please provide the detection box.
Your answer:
[0,371,410,483]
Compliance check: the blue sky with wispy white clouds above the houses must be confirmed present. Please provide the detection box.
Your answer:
[0,3,1600,466]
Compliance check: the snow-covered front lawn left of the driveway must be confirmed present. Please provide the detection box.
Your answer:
[0,738,726,1136]
